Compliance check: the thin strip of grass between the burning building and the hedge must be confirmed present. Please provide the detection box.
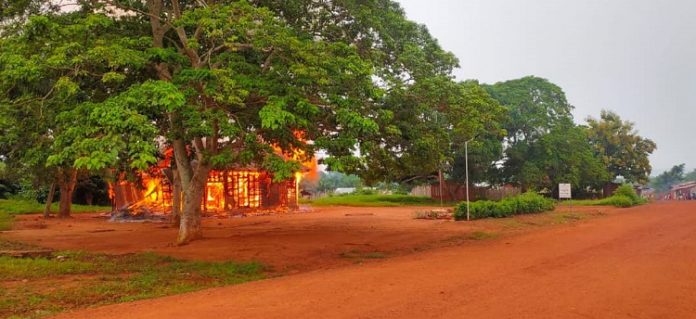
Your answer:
[307,194,439,207]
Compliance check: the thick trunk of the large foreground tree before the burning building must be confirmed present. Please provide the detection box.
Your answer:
[176,165,209,245]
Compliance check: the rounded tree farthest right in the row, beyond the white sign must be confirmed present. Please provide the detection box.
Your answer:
[587,110,657,183]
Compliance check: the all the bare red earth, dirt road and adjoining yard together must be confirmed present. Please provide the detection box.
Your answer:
[3,202,696,318]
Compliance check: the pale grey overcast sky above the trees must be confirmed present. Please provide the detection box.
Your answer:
[398,0,696,174]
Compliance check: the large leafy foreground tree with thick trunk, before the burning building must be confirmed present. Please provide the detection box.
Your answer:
[64,0,378,243]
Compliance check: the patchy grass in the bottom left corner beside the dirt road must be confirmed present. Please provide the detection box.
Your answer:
[0,244,265,318]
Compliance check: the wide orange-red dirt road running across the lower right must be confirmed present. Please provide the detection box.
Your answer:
[55,202,696,319]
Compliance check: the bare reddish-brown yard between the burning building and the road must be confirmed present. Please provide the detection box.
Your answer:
[0,207,604,274]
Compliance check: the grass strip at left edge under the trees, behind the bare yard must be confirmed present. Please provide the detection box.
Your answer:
[0,199,111,231]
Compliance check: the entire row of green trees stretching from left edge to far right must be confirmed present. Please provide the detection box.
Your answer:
[0,0,655,244]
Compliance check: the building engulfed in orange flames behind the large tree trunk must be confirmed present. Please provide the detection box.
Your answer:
[109,148,316,215]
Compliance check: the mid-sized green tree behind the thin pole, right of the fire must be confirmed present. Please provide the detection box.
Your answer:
[362,79,505,186]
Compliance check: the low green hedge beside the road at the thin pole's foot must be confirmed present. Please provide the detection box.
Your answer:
[454,192,554,220]
